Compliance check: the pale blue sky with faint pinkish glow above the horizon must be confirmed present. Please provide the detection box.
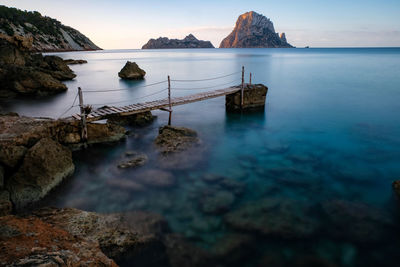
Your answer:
[0,0,400,49]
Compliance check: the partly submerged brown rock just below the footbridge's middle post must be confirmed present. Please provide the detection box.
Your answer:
[155,126,199,154]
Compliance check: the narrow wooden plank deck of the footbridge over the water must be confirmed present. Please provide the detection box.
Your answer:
[72,86,240,121]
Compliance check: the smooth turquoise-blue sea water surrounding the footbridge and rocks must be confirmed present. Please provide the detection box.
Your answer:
[2,48,400,266]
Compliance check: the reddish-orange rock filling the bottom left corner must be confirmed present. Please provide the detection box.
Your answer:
[0,215,117,267]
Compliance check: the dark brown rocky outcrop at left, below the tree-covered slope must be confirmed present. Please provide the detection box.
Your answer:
[0,36,76,98]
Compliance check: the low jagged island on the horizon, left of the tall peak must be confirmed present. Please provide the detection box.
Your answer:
[142,34,214,49]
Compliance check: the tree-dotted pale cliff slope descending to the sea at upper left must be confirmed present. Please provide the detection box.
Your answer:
[0,6,101,52]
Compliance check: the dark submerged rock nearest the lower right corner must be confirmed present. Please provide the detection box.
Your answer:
[322,200,394,244]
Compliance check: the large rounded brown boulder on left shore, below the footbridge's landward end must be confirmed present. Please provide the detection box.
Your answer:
[6,138,75,209]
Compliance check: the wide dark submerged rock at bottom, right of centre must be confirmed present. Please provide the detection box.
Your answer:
[225,198,319,239]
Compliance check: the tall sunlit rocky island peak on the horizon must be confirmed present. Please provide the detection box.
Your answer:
[219,11,293,48]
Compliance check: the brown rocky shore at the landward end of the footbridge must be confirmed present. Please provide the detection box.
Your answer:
[0,114,126,215]
